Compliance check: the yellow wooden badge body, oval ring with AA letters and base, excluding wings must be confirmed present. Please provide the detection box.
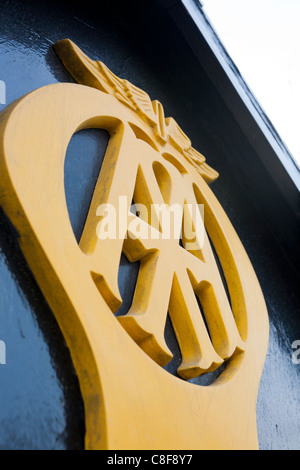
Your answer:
[0,43,268,449]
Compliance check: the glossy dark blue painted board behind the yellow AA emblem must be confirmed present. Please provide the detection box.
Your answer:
[0,0,300,449]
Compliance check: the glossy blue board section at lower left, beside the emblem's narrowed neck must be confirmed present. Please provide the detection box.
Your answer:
[0,211,84,449]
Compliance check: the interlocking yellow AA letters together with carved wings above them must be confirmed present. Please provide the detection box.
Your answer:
[56,40,246,379]
